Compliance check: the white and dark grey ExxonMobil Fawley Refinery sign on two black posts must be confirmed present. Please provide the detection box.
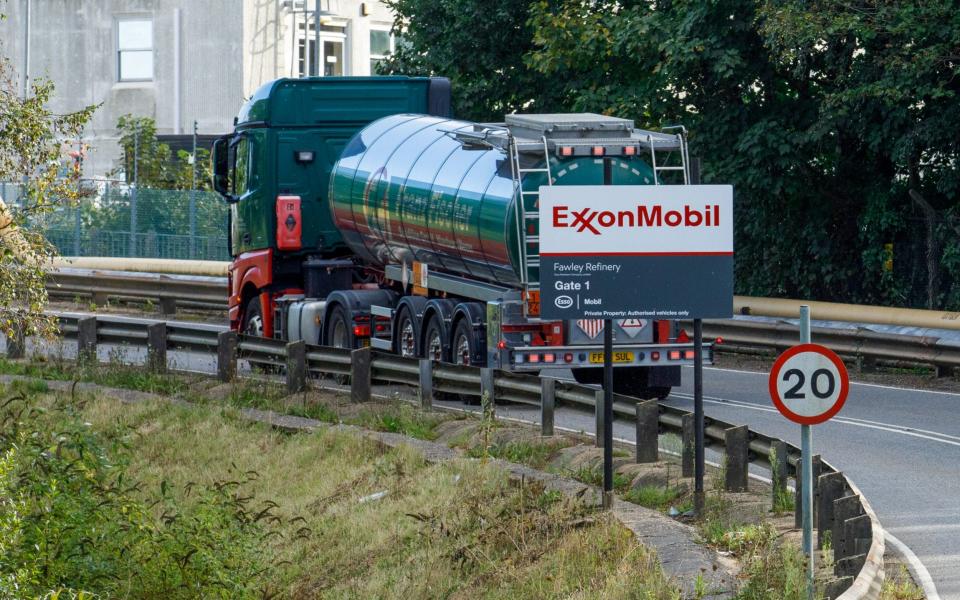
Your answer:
[539,184,733,514]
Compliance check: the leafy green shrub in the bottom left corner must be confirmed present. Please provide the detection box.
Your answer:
[0,394,292,598]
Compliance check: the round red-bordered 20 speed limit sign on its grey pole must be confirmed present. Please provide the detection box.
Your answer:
[768,305,850,599]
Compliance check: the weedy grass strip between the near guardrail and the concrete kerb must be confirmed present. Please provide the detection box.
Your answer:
[0,359,923,600]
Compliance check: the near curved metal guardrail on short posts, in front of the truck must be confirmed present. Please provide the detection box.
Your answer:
[22,314,884,600]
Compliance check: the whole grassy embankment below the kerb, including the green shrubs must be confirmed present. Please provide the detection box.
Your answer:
[0,383,676,598]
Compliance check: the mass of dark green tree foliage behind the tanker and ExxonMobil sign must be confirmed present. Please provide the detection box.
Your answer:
[391,0,960,308]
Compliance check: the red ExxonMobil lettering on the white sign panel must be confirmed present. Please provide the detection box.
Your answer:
[553,204,720,235]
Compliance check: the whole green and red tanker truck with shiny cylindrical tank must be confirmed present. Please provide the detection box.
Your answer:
[212,76,712,398]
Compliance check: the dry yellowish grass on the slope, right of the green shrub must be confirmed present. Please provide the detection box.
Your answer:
[73,398,677,599]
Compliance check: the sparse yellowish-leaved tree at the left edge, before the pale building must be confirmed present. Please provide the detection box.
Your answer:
[0,41,96,336]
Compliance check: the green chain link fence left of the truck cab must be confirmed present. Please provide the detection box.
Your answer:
[0,181,230,260]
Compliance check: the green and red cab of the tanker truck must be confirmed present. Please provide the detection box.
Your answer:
[211,76,450,335]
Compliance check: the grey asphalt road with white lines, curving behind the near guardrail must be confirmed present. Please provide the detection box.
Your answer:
[9,322,960,600]
